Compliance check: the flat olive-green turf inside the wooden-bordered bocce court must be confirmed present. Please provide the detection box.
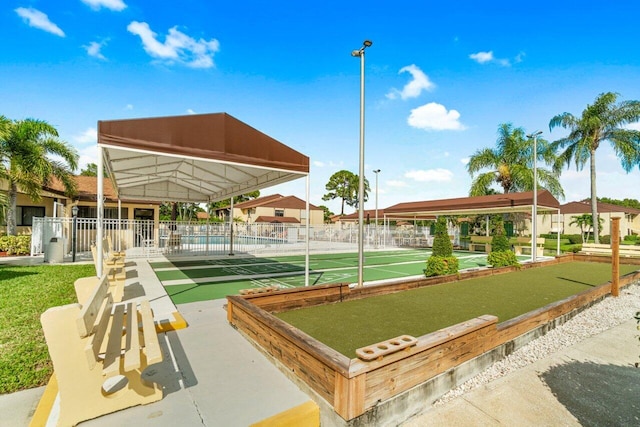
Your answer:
[276,262,638,357]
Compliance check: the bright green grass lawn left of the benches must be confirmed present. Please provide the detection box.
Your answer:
[0,264,96,394]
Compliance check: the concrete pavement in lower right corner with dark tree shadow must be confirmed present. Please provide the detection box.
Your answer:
[403,320,640,427]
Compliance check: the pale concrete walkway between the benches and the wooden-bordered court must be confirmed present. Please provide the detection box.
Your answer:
[0,260,310,427]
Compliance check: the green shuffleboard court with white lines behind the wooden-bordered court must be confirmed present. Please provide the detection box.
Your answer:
[150,249,528,304]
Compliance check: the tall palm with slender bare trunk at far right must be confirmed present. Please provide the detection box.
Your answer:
[549,92,640,243]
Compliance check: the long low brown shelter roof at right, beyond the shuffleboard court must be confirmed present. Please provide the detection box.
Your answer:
[385,190,560,217]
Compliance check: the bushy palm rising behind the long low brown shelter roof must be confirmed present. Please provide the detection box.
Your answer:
[467,123,564,197]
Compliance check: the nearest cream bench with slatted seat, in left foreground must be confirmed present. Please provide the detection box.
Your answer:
[40,275,162,426]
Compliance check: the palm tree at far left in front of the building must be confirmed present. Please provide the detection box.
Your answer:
[0,116,78,235]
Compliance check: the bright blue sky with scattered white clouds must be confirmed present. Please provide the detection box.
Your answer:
[0,0,640,213]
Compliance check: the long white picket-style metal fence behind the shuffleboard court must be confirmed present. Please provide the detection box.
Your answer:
[31,218,450,260]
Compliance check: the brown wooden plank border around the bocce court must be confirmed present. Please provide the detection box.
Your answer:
[227,254,640,421]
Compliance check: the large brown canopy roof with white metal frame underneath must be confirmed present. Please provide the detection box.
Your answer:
[98,113,309,202]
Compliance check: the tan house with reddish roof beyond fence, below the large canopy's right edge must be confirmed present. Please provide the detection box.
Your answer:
[233,194,324,225]
